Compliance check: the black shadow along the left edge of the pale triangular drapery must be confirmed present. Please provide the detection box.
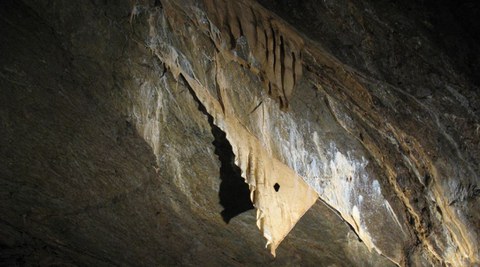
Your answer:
[184,80,254,223]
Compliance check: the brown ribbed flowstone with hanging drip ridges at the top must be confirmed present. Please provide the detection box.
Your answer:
[203,0,303,109]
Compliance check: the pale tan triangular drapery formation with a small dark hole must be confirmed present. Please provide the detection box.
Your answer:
[155,38,318,255]
